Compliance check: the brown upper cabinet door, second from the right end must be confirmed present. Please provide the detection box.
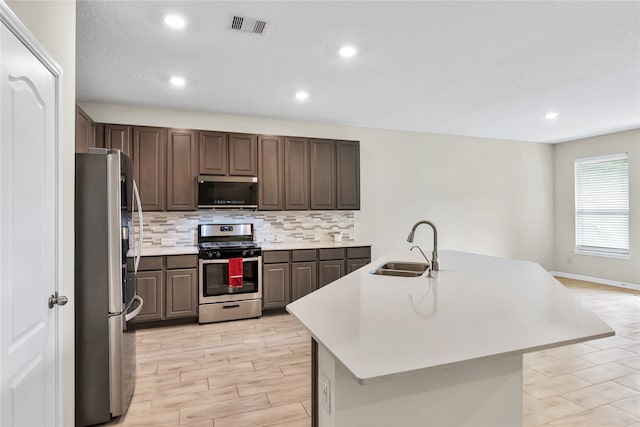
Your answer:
[309,139,336,209]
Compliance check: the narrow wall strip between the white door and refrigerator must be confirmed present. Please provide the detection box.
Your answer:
[6,0,76,426]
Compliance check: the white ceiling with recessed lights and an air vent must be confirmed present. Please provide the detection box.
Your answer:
[76,1,640,142]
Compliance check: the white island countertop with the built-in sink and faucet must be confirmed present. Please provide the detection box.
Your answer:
[287,251,614,384]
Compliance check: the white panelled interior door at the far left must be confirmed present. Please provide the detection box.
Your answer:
[0,10,59,427]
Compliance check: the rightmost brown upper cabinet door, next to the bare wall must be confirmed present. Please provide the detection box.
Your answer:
[336,141,360,210]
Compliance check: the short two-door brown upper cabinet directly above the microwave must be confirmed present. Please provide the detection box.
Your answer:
[198,131,258,176]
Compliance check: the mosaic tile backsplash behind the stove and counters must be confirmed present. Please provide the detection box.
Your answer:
[136,210,355,248]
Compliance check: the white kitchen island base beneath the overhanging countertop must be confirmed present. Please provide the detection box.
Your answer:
[317,344,522,427]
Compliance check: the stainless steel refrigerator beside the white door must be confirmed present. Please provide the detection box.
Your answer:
[74,149,143,426]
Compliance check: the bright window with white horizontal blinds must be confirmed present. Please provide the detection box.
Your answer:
[575,153,629,256]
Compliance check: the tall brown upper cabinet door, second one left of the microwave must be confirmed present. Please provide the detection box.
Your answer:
[133,127,165,211]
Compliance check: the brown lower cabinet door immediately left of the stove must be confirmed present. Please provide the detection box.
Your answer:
[166,268,198,319]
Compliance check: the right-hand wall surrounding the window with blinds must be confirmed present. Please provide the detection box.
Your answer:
[554,129,640,284]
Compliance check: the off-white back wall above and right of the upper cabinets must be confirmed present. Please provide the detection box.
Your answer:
[81,103,553,268]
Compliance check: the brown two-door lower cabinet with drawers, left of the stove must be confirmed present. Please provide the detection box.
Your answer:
[136,255,198,323]
